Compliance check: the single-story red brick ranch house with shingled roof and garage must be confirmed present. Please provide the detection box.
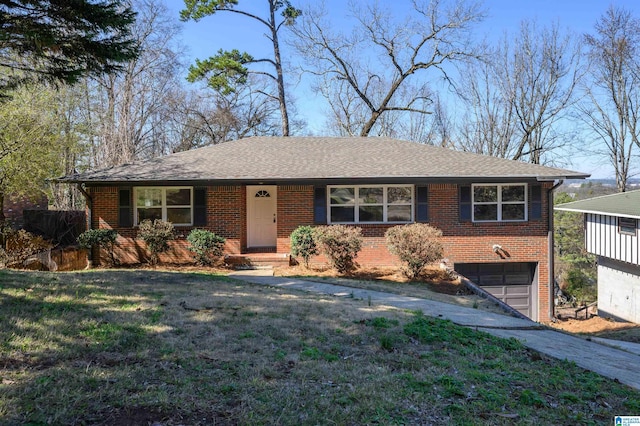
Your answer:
[62,137,588,321]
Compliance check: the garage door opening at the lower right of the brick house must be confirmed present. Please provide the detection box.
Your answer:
[455,263,538,321]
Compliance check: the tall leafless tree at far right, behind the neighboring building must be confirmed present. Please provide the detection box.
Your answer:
[580,6,640,192]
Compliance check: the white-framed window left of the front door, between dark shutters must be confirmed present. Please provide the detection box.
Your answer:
[134,186,193,226]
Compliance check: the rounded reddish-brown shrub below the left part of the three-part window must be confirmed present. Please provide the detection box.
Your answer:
[314,225,362,274]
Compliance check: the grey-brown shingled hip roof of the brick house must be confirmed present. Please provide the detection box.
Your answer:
[60,137,589,183]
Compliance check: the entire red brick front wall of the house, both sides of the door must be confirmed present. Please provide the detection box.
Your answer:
[90,183,551,320]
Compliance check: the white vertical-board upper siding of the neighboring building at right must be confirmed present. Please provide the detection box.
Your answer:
[585,213,640,265]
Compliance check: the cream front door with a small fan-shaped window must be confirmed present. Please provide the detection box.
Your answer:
[247,185,278,247]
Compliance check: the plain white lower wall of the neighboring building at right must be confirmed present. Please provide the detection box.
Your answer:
[598,257,640,323]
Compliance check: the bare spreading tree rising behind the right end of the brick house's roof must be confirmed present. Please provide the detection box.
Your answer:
[460,21,584,164]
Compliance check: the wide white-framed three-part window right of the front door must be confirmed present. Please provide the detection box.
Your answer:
[327,185,413,223]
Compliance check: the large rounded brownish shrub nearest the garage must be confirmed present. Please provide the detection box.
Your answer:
[385,223,444,279]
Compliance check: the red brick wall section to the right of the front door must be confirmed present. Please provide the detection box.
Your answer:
[278,183,552,321]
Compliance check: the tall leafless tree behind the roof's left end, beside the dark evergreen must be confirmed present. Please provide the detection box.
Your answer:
[85,0,182,166]
